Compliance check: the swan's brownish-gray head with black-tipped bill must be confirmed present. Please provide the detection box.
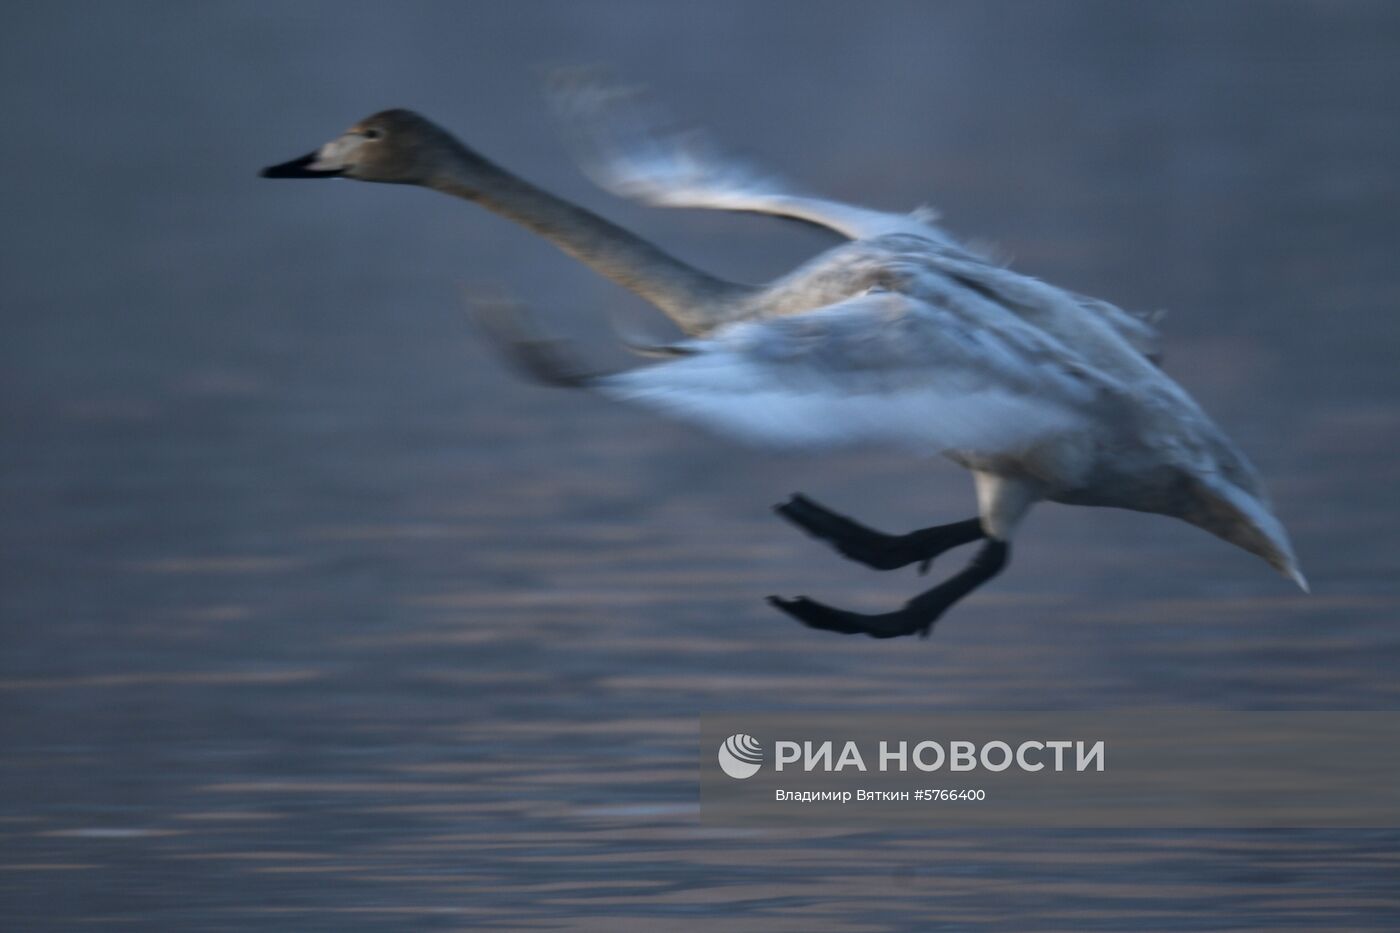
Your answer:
[259,109,472,185]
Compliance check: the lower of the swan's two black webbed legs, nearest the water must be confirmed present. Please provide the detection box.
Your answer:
[769,538,1011,639]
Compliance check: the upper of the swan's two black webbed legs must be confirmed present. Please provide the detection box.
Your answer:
[773,493,986,573]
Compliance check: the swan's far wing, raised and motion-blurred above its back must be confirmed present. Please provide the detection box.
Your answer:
[554,74,956,247]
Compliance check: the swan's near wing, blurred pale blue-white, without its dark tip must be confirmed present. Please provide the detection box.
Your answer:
[591,293,1095,454]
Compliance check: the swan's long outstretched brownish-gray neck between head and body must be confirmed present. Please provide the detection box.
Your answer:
[427,148,752,333]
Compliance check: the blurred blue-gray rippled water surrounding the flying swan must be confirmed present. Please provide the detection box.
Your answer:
[0,1,1400,932]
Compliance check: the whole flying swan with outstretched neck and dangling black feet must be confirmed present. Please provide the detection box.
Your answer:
[262,84,1308,639]
